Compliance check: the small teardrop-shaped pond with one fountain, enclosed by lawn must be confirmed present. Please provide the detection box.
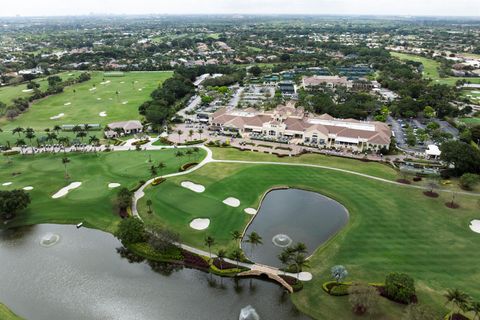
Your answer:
[242,189,348,267]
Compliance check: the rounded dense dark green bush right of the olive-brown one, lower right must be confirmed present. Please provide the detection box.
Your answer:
[385,272,415,304]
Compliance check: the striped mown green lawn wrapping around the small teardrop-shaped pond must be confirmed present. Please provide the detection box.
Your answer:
[140,163,480,319]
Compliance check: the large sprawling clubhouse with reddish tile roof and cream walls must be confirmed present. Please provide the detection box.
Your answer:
[209,103,392,152]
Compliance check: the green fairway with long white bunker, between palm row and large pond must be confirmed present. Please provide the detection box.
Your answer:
[0,149,205,232]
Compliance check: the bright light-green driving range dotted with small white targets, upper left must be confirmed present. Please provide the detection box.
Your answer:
[0,72,172,131]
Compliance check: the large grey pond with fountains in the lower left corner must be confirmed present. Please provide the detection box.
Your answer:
[0,225,308,320]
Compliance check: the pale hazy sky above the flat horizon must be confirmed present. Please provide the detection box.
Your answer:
[0,0,480,16]
